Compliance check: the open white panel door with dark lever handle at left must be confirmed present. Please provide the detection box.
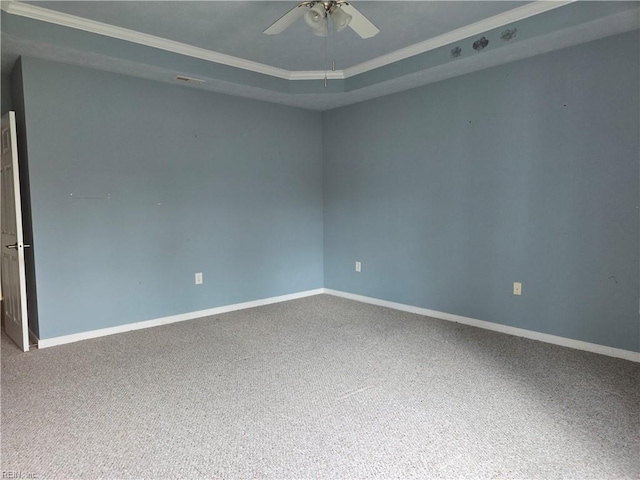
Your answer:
[0,112,29,352]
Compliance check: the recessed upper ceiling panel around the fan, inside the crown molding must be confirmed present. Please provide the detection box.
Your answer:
[29,1,530,71]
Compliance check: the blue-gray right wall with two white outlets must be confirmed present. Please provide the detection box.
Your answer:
[323,31,640,351]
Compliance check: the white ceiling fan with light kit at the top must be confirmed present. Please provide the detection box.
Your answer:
[264,0,380,38]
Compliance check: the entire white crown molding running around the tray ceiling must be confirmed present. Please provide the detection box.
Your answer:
[1,0,577,80]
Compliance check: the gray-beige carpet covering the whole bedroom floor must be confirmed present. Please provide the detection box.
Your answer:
[2,295,640,479]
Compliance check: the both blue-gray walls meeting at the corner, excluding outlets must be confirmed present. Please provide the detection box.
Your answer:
[13,31,640,351]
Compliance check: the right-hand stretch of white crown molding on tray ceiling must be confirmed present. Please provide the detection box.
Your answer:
[344,0,577,78]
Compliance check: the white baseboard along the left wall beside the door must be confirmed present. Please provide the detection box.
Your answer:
[38,288,324,348]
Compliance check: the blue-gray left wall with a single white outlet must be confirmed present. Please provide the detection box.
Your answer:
[22,58,323,339]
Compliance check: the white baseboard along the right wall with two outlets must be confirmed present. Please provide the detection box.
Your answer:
[324,288,640,362]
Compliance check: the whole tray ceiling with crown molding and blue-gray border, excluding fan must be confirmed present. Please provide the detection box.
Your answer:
[2,0,640,110]
